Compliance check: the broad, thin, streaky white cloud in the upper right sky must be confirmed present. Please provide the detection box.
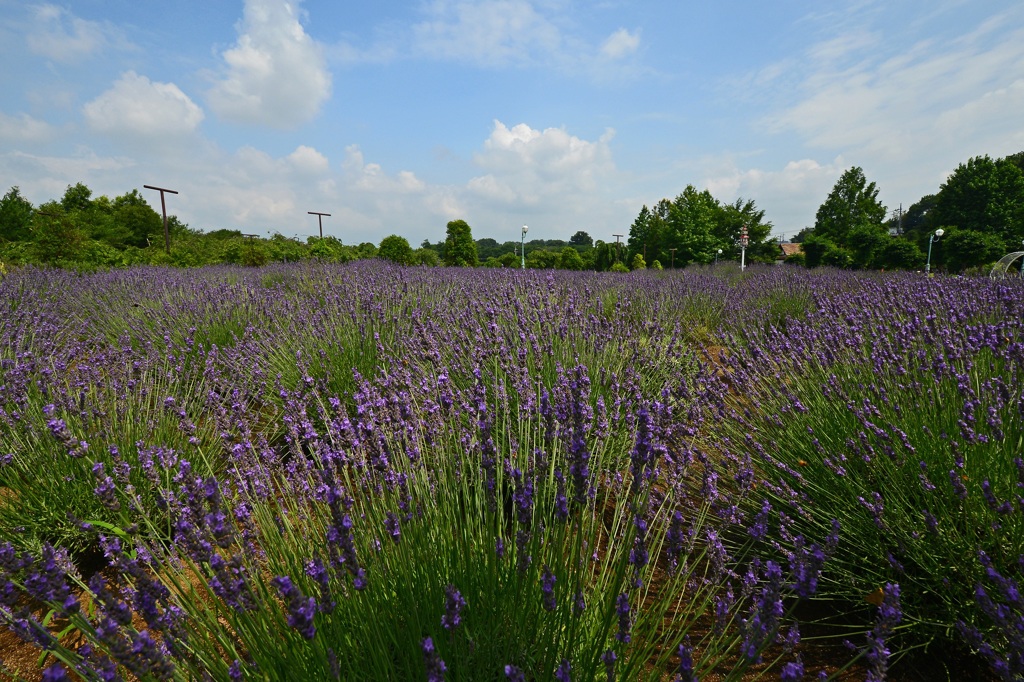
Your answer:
[766,10,1024,160]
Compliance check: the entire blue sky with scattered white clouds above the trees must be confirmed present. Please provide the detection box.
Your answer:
[0,0,1024,246]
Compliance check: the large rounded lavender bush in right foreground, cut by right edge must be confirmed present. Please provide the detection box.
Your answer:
[716,268,1024,671]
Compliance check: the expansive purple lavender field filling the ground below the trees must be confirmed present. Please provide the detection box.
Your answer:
[0,261,1024,682]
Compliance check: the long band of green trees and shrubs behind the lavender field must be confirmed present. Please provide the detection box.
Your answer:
[0,152,1024,272]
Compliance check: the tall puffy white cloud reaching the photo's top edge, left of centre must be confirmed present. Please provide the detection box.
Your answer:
[208,0,331,128]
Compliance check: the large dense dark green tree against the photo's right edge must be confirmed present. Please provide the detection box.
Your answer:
[933,156,1024,245]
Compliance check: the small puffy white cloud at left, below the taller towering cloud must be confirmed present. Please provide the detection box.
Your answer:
[82,71,203,137]
